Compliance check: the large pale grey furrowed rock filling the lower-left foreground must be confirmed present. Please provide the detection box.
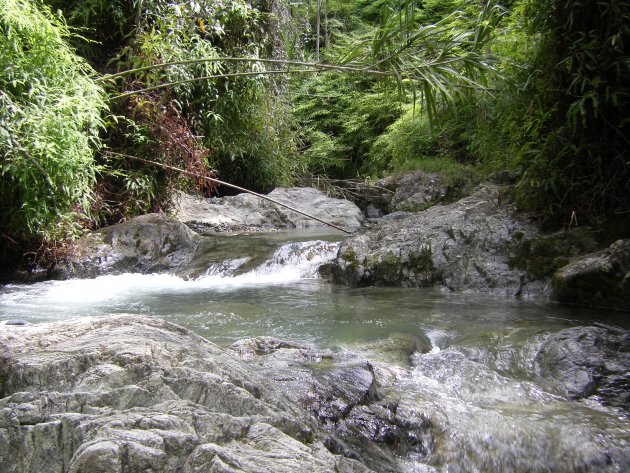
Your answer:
[0,315,431,473]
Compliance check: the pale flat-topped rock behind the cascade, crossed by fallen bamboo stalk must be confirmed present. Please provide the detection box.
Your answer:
[175,187,363,233]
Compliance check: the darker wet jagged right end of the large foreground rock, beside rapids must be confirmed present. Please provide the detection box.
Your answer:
[231,337,434,472]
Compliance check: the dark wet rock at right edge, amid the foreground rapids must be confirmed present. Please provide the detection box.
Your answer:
[534,327,630,410]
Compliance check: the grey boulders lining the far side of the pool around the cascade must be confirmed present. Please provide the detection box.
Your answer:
[34,179,630,310]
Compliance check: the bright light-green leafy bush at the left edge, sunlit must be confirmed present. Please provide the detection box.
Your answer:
[0,0,106,247]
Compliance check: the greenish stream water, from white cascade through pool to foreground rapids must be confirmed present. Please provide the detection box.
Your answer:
[0,230,630,473]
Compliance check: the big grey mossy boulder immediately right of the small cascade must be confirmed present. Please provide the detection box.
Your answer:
[327,185,544,298]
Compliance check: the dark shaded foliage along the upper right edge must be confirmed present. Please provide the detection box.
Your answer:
[518,0,630,224]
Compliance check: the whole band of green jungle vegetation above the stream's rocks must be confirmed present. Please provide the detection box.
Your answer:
[0,0,630,272]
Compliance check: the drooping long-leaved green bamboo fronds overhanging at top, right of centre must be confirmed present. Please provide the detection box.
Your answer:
[341,0,500,112]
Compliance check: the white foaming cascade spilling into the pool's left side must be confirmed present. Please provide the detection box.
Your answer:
[0,240,339,320]
